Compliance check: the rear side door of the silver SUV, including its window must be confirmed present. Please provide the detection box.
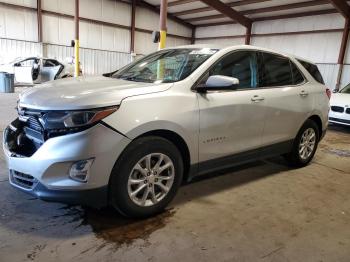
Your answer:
[259,52,312,146]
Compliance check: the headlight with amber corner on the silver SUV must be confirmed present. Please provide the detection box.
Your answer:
[42,107,118,129]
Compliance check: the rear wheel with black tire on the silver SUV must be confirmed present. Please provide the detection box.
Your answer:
[285,119,320,167]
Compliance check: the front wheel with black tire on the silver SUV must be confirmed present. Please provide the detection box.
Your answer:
[109,136,184,218]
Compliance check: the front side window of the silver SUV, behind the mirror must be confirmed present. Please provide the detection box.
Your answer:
[209,51,257,88]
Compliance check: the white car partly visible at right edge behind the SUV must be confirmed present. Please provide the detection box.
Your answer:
[329,84,350,126]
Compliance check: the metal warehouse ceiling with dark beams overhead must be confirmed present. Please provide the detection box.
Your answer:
[145,0,350,26]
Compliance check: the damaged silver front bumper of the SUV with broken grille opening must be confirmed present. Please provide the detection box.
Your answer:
[3,120,130,207]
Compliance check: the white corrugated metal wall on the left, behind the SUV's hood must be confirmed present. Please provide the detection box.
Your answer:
[0,0,192,75]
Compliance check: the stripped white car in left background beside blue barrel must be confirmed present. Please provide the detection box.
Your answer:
[0,57,74,84]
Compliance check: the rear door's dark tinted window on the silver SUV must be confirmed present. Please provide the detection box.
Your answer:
[261,53,293,87]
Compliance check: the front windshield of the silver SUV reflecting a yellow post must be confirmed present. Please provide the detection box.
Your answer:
[111,48,218,83]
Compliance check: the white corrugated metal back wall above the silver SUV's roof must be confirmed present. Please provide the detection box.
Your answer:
[196,14,350,88]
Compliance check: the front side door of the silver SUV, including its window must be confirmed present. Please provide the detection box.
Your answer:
[198,51,265,173]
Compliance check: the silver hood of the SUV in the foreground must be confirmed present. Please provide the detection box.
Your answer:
[19,76,173,110]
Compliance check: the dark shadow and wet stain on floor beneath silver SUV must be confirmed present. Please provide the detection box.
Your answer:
[0,158,288,252]
